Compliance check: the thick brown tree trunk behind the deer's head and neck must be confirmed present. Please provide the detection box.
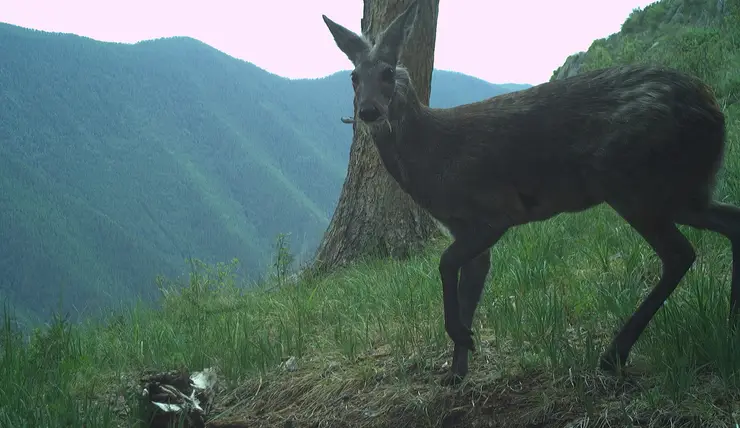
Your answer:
[315,0,441,270]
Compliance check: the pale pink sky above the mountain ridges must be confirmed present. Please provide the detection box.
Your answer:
[0,0,652,84]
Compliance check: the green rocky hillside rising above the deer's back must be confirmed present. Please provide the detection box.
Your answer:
[568,0,740,105]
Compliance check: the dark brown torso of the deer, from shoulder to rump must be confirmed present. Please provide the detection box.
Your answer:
[424,66,724,226]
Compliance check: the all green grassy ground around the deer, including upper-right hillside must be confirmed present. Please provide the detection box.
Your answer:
[0,0,740,427]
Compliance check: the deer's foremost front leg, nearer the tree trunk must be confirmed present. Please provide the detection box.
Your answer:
[439,226,506,354]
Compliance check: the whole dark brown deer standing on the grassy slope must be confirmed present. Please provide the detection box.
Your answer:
[322,0,740,385]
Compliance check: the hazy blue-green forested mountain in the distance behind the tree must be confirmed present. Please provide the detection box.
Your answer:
[0,20,532,317]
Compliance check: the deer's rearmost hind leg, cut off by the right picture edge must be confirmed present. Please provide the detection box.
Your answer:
[678,202,740,324]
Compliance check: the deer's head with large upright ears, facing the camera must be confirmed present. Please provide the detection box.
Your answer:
[322,1,418,123]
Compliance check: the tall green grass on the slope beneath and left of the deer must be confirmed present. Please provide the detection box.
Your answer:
[0,109,740,427]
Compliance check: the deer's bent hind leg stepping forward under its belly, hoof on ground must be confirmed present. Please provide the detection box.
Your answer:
[600,204,696,371]
